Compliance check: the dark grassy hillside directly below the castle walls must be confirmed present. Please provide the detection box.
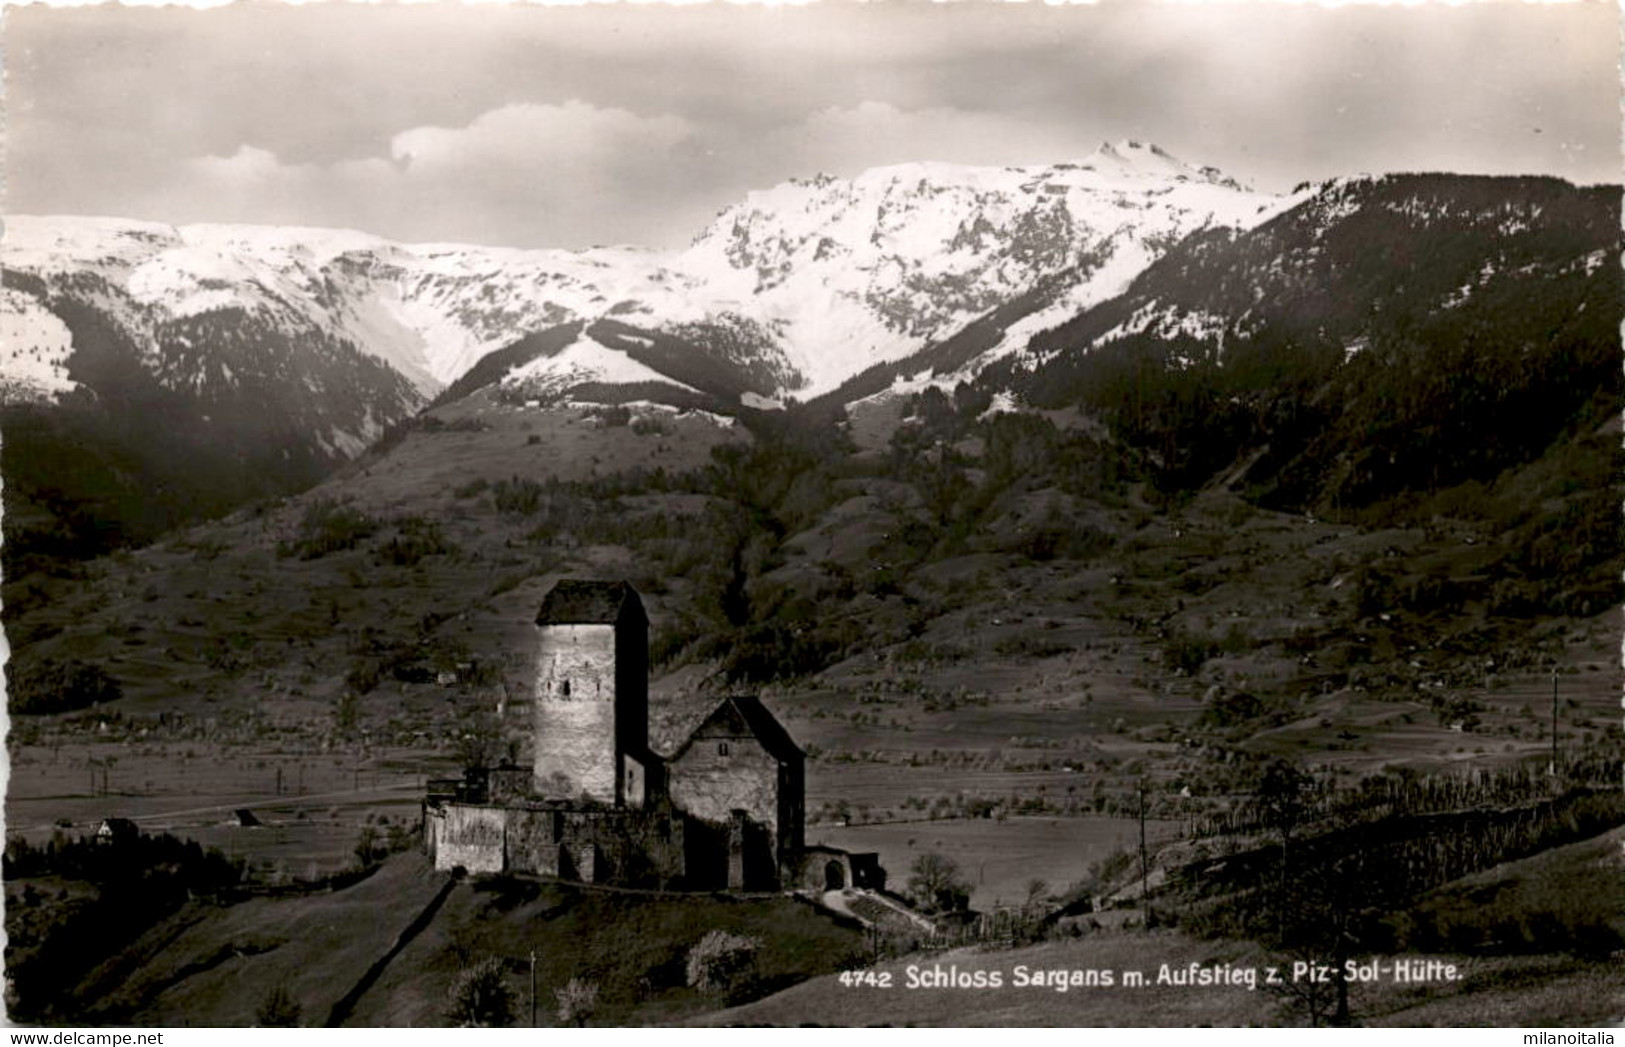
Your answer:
[54,855,861,1026]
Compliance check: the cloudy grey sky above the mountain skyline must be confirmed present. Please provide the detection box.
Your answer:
[0,0,1622,249]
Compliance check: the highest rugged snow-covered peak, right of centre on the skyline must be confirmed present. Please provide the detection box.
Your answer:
[679,141,1287,395]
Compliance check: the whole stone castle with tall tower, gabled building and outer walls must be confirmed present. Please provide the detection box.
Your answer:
[424,580,884,891]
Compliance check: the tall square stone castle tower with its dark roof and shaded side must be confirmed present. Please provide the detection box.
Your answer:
[531,579,652,806]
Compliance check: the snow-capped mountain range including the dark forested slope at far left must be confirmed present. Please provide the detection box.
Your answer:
[0,143,1290,567]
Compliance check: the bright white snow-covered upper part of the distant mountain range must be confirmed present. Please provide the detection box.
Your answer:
[0,143,1282,411]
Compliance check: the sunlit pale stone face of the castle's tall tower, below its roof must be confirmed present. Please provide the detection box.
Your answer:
[531,624,621,803]
